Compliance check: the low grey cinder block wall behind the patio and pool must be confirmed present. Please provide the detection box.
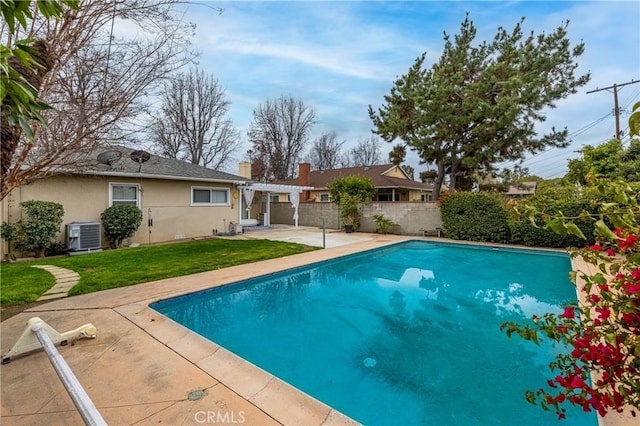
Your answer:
[271,202,442,235]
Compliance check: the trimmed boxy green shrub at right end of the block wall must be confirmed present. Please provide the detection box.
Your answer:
[440,192,509,243]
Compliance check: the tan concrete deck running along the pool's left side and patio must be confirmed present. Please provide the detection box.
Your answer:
[0,229,640,426]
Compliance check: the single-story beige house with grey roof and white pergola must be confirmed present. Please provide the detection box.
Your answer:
[0,146,309,257]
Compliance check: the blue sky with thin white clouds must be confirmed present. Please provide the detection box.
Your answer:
[172,0,640,179]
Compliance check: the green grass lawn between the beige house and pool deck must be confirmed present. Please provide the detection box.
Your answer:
[0,238,317,305]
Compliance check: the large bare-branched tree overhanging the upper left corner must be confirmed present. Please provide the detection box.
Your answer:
[0,0,192,198]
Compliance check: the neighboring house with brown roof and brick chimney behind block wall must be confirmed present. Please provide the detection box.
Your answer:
[272,163,433,202]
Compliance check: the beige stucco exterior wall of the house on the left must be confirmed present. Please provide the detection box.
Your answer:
[0,176,239,257]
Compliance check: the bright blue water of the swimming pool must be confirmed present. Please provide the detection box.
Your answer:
[152,241,596,426]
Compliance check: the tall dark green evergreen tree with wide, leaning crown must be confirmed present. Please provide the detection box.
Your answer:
[369,16,590,198]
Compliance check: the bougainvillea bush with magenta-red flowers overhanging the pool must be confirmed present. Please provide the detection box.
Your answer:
[501,181,640,419]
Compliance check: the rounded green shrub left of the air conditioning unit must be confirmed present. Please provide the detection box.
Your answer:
[1,200,64,257]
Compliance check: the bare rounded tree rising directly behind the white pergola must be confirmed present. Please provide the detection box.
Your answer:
[248,96,316,181]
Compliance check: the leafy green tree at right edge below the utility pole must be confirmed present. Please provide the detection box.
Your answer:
[565,138,640,185]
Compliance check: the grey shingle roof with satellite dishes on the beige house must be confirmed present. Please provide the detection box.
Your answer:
[82,146,250,182]
